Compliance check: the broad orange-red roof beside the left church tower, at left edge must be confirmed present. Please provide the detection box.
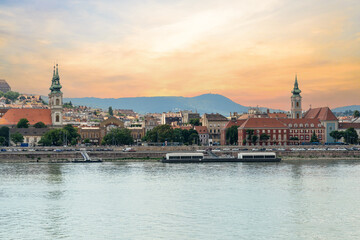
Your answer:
[0,108,52,125]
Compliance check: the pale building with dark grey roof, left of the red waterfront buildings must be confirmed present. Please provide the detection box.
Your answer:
[201,113,229,145]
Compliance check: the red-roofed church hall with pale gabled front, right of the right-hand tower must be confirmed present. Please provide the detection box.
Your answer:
[304,107,339,143]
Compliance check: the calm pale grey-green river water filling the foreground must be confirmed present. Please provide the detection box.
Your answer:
[0,160,360,240]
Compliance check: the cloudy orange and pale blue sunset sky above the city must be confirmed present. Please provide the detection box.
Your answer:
[0,0,360,110]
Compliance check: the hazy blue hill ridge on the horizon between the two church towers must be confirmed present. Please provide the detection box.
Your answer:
[43,94,281,116]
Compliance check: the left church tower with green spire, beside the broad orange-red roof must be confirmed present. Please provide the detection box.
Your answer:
[49,64,63,126]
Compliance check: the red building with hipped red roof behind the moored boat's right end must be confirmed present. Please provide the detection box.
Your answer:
[238,118,289,146]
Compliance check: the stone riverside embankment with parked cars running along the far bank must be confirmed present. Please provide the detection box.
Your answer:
[0,146,360,163]
